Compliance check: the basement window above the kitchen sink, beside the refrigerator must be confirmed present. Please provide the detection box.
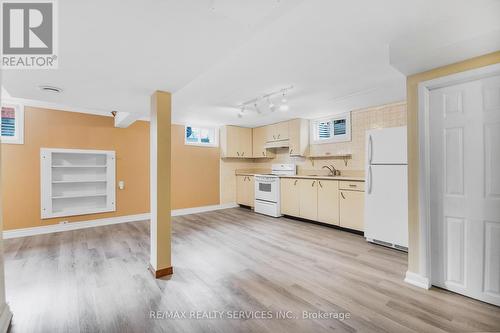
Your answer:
[311,112,351,144]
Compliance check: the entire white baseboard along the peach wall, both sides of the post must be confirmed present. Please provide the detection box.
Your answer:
[3,202,238,239]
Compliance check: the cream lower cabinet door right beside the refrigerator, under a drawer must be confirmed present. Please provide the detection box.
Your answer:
[339,190,365,231]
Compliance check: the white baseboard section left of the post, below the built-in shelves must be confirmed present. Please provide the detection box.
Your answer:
[3,213,149,239]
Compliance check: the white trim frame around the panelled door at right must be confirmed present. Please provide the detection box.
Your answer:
[416,63,500,289]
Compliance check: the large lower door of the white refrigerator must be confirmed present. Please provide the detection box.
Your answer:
[365,165,408,248]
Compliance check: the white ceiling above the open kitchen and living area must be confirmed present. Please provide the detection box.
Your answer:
[3,0,500,126]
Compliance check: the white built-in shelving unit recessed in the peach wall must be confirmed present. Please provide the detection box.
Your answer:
[40,148,116,219]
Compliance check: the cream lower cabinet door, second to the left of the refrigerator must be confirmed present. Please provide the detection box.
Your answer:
[318,180,340,225]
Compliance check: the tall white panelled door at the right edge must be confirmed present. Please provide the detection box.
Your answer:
[429,76,500,305]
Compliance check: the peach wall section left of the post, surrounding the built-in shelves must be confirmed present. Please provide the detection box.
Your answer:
[1,106,149,230]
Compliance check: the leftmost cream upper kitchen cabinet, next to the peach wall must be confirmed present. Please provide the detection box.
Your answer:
[220,125,253,158]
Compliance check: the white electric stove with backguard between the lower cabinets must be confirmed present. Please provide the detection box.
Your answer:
[254,164,297,217]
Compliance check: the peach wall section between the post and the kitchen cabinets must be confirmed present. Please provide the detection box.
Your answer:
[172,125,220,209]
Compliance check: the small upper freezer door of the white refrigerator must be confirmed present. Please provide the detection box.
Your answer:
[366,127,407,164]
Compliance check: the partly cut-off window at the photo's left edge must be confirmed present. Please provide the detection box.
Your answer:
[1,102,24,144]
